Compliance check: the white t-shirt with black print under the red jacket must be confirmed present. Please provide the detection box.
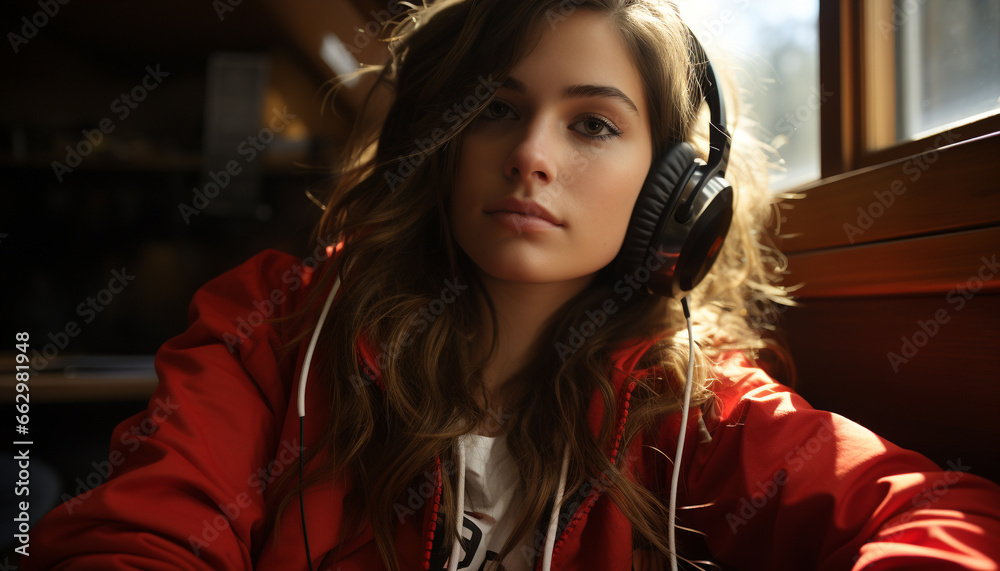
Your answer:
[445,434,534,571]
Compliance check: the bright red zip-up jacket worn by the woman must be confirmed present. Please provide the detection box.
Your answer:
[21,250,1000,571]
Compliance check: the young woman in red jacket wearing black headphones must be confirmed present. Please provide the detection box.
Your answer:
[23,0,1000,571]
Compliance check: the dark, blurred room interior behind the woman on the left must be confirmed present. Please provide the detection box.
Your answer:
[0,0,396,568]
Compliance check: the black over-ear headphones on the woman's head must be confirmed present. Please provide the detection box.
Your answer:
[614,28,733,298]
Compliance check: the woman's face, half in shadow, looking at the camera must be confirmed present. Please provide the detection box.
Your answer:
[450,9,652,283]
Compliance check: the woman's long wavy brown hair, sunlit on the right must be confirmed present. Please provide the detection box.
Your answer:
[269,0,794,570]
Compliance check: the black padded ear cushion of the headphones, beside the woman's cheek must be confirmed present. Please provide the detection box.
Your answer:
[616,142,697,274]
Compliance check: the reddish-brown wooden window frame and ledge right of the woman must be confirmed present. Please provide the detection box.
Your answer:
[781,0,1000,297]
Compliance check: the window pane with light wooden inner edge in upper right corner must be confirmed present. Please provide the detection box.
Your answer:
[862,0,1000,150]
